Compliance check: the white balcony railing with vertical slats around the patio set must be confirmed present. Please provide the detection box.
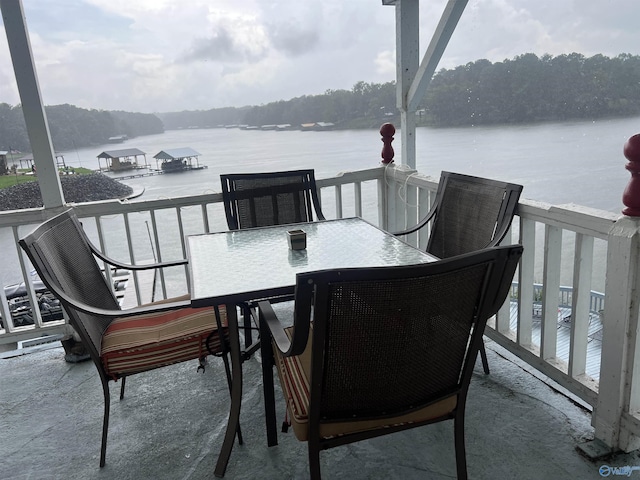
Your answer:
[0,161,640,449]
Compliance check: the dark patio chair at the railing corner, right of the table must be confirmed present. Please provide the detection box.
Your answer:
[394,172,522,374]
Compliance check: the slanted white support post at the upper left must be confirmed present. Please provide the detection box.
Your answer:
[0,0,65,208]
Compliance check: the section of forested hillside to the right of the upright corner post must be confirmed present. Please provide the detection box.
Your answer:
[424,53,640,126]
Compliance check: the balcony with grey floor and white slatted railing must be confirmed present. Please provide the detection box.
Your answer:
[0,158,640,478]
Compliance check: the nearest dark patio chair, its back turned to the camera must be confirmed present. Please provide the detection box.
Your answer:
[258,245,522,479]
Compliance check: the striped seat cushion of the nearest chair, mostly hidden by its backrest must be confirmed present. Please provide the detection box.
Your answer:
[273,324,457,441]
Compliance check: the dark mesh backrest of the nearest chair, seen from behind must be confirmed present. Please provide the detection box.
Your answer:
[294,245,522,428]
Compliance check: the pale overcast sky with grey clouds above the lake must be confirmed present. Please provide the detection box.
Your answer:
[0,0,640,112]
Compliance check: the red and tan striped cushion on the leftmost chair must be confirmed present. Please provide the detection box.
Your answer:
[100,299,228,379]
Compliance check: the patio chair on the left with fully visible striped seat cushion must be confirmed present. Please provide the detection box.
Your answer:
[20,210,236,467]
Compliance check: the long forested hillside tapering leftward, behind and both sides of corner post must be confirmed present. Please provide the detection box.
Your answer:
[160,53,640,129]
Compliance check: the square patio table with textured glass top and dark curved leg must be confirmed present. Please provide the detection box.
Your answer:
[187,218,436,477]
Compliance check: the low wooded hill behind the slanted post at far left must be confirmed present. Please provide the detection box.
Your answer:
[0,103,164,152]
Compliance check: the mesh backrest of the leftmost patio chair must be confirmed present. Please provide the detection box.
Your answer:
[20,210,120,361]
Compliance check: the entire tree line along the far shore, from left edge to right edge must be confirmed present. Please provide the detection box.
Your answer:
[0,53,640,151]
